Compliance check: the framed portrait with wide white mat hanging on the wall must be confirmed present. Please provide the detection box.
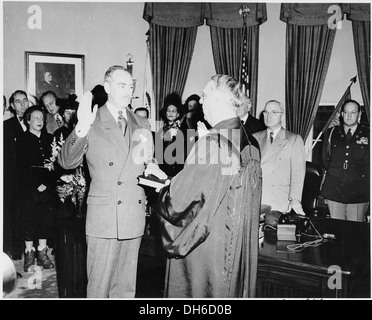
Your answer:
[25,51,85,98]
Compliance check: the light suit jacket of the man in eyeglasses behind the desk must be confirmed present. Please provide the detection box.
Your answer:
[253,128,306,212]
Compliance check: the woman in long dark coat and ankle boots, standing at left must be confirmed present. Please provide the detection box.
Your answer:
[17,106,57,272]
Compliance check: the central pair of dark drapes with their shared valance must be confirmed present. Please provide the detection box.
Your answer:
[143,2,267,119]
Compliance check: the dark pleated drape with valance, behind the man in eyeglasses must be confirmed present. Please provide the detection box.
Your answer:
[280,3,337,140]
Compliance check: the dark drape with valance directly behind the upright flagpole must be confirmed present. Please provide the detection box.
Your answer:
[204,3,267,116]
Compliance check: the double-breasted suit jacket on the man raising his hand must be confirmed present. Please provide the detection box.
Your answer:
[58,105,153,239]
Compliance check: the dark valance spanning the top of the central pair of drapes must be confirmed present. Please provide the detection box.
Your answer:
[143,2,267,28]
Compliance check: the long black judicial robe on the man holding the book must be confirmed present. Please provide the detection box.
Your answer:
[156,118,262,298]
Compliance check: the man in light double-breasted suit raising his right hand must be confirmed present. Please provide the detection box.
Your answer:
[58,66,167,298]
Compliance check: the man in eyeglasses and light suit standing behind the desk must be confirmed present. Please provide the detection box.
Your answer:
[253,100,306,215]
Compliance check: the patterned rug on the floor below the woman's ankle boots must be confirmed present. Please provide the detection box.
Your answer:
[4,248,58,299]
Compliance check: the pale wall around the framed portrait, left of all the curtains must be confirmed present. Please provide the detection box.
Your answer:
[3,2,148,106]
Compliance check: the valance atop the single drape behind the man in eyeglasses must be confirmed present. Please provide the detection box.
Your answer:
[280,3,341,26]
